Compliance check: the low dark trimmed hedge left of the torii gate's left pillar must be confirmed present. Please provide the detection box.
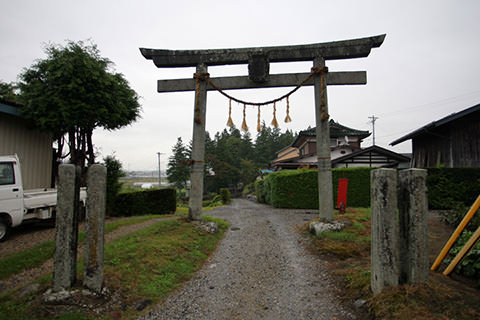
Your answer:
[111,188,177,217]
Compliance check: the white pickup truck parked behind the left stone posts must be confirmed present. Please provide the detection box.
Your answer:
[0,155,86,241]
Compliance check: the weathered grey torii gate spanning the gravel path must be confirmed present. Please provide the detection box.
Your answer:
[140,34,385,221]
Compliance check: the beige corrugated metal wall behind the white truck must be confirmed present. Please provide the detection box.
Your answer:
[0,113,53,189]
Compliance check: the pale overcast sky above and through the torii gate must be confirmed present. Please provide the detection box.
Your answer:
[0,0,480,170]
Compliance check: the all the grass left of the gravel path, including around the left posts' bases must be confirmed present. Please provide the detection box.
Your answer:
[0,217,229,319]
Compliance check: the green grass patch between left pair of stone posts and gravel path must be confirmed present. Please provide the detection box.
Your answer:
[105,218,228,301]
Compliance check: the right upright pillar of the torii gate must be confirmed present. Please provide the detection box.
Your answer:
[313,57,333,221]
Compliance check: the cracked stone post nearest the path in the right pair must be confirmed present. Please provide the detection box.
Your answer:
[370,168,400,294]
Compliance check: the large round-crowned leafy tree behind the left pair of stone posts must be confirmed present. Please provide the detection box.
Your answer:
[18,41,140,171]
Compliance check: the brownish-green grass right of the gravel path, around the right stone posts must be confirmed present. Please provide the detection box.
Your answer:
[304,208,480,320]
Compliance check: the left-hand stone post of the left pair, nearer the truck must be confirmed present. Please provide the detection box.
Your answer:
[53,164,80,292]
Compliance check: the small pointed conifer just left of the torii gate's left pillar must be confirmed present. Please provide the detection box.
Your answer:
[167,137,190,189]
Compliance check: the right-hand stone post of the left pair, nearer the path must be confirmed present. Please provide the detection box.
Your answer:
[83,164,107,292]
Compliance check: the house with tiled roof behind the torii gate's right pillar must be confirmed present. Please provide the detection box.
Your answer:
[271,119,410,170]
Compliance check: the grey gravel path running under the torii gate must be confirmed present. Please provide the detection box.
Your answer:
[139,200,355,320]
